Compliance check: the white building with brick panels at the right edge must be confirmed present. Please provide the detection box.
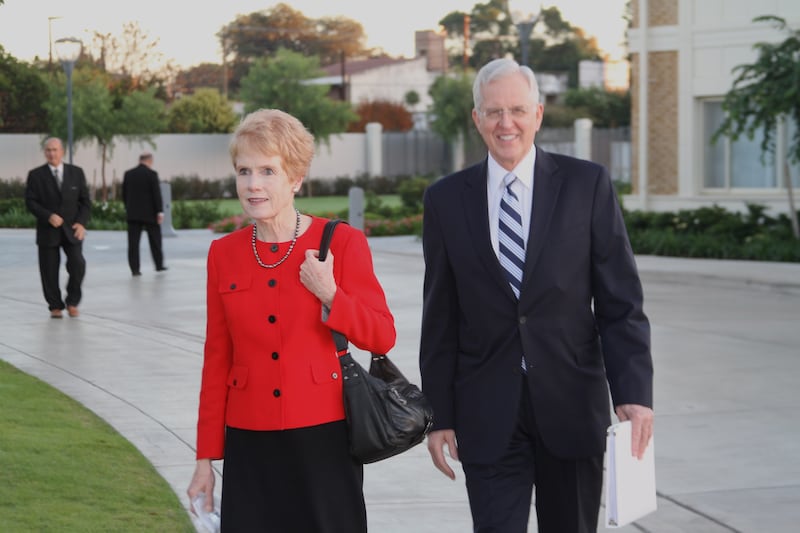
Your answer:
[625,0,800,212]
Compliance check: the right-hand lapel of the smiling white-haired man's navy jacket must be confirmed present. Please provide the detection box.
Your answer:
[520,146,562,298]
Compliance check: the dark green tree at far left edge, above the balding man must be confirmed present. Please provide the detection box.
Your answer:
[0,46,48,133]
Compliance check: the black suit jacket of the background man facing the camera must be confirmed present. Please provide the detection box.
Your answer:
[25,163,92,246]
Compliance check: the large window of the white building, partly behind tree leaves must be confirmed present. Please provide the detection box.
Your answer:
[703,101,780,189]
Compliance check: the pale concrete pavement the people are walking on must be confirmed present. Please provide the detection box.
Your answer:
[0,229,800,533]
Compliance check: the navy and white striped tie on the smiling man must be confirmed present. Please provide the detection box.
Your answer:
[497,173,525,299]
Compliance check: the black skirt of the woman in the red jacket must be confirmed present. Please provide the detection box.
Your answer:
[221,421,367,533]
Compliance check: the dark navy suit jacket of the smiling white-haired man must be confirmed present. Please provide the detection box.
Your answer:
[420,148,653,464]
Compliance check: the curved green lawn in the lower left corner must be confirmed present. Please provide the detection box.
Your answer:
[0,361,195,533]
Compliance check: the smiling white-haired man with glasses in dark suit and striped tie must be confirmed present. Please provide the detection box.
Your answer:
[420,59,653,533]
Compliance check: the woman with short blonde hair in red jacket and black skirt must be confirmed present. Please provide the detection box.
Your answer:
[187,110,396,533]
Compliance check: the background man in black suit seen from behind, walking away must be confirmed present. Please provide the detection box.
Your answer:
[122,150,167,276]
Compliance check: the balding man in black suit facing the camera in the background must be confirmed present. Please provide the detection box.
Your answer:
[25,137,92,318]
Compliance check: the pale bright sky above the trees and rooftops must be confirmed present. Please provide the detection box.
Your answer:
[0,0,626,68]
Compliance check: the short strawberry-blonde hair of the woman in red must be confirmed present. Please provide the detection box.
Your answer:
[229,109,314,181]
